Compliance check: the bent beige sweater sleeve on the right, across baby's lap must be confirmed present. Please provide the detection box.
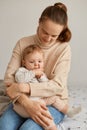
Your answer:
[30,46,71,98]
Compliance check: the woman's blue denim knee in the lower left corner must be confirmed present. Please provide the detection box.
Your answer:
[0,104,23,130]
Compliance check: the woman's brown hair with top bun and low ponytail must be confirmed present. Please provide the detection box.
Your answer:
[39,3,71,43]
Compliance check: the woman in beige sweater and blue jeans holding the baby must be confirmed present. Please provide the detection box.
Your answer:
[0,3,71,130]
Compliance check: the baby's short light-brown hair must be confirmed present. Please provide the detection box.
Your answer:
[22,44,43,60]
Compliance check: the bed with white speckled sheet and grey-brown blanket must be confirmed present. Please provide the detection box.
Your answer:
[0,80,87,130]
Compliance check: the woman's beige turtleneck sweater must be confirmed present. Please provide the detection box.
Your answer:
[4,35,71,101]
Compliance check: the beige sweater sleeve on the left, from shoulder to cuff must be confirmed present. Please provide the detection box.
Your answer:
[4,36,34,83]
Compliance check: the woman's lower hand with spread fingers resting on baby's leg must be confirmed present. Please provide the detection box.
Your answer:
[21,95,52,128]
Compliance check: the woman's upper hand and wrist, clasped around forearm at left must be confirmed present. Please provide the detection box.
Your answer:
[6,83,30,99]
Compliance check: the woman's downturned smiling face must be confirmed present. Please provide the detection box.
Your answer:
[38,20,64,45]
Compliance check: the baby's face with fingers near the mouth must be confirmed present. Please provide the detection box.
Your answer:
[24,51,44,70]
